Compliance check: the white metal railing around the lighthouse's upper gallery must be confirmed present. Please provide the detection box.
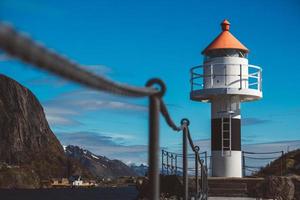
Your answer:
[190,64,262,91]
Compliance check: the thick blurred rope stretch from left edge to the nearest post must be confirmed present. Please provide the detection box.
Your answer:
[0,24,158,97]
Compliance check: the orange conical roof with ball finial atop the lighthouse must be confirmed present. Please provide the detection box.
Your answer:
[202,19,249,54]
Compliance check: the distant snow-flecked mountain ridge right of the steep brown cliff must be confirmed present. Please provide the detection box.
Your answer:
[65,145,137,178]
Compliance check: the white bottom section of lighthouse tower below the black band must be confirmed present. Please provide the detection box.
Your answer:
[211,151,243,178]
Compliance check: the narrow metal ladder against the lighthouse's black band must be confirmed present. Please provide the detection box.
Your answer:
[221,111,233,156]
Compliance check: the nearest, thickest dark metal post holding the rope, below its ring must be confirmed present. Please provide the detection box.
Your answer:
[148,95,160,200]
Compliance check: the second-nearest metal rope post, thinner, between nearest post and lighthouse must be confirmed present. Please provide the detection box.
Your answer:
[182,127,189,200]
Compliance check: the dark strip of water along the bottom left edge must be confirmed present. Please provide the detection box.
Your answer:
[0,187,138,200]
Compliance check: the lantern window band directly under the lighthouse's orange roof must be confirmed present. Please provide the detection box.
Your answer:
[205,49,248,60]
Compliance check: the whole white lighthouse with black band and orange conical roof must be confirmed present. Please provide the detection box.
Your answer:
[190,20,262,177]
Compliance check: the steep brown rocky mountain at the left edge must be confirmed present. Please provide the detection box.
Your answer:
[0,74,89,188]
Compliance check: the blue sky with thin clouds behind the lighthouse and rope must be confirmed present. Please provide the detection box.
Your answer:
[0,0,300,162]
